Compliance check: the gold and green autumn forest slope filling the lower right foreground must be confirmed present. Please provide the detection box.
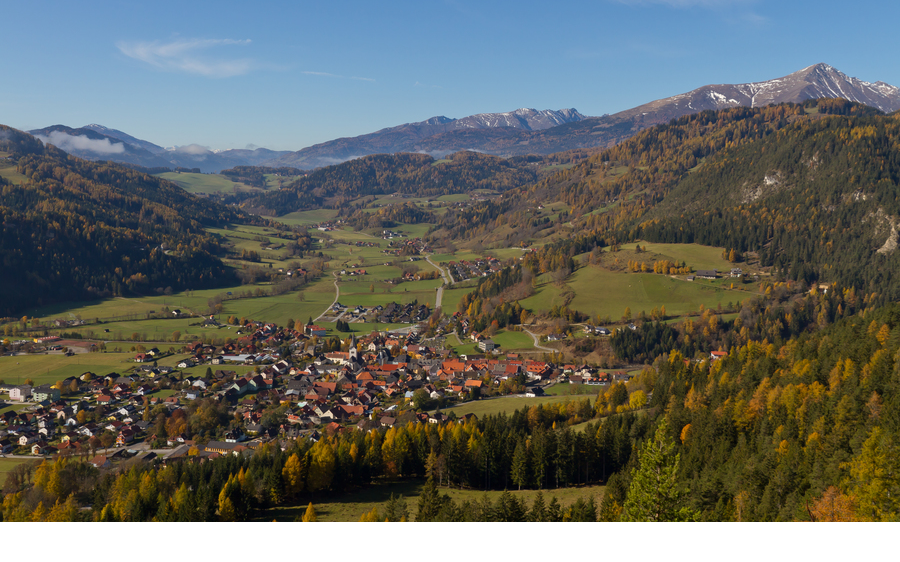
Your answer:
[653,305,900,521]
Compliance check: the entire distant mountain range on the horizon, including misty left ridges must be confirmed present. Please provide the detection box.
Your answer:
[30,64,900,173]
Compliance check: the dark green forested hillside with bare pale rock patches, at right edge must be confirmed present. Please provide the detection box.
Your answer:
[632,107,900,296]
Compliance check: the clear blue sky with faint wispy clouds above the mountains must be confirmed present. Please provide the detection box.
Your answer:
[0,0,900,150]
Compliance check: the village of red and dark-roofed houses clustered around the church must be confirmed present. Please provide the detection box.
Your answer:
[0,307,627,466]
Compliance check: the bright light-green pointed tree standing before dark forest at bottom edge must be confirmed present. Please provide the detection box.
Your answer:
[620,417,697,521]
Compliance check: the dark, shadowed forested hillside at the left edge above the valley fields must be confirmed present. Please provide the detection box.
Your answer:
[0,125,260,316]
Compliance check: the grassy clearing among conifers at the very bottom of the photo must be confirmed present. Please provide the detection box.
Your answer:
[254,480,605,523]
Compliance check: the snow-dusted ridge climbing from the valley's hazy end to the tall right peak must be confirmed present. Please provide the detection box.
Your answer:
[266,64,900,169]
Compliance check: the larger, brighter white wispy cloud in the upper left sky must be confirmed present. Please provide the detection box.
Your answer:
[116,39,255,78]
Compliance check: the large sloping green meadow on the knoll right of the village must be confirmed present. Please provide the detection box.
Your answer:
[520,267,749,321]
